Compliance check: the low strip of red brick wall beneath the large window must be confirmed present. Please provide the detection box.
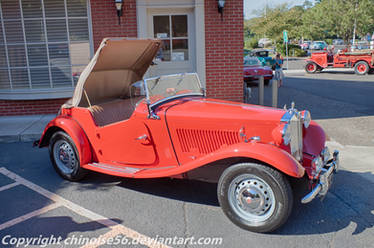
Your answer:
[0,99,67,116]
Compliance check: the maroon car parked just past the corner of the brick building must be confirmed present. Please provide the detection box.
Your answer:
[243,56,273,85]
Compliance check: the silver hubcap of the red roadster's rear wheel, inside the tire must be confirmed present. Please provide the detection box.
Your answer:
[53,140,77,174]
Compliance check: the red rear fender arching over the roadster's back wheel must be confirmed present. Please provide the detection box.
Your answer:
[39,116,92,165]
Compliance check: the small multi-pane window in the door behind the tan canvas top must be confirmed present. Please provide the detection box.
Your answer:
[153,15,189,61]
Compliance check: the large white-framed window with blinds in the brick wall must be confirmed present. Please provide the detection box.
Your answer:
[0,0,91,96]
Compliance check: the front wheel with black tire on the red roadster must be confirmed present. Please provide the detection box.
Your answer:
[217,163,293,233]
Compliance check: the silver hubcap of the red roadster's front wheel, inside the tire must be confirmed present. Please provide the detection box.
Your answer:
[228,174,275,222]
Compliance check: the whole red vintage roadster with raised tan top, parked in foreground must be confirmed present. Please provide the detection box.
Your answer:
[35,39,339,232]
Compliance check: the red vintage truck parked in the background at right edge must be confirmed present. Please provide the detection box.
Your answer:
[305,49,374,75]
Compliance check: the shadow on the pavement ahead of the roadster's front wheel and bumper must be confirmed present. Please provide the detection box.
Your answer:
[274,170,374,235]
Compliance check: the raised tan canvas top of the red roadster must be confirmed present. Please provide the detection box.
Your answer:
[63,38,160,108]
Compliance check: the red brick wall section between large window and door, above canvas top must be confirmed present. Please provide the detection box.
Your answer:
[91,0,138,50]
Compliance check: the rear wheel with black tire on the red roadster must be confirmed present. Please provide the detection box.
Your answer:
[49,131,86,181]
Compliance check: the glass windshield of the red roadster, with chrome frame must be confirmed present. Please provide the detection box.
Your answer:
[144,73,204,104]
